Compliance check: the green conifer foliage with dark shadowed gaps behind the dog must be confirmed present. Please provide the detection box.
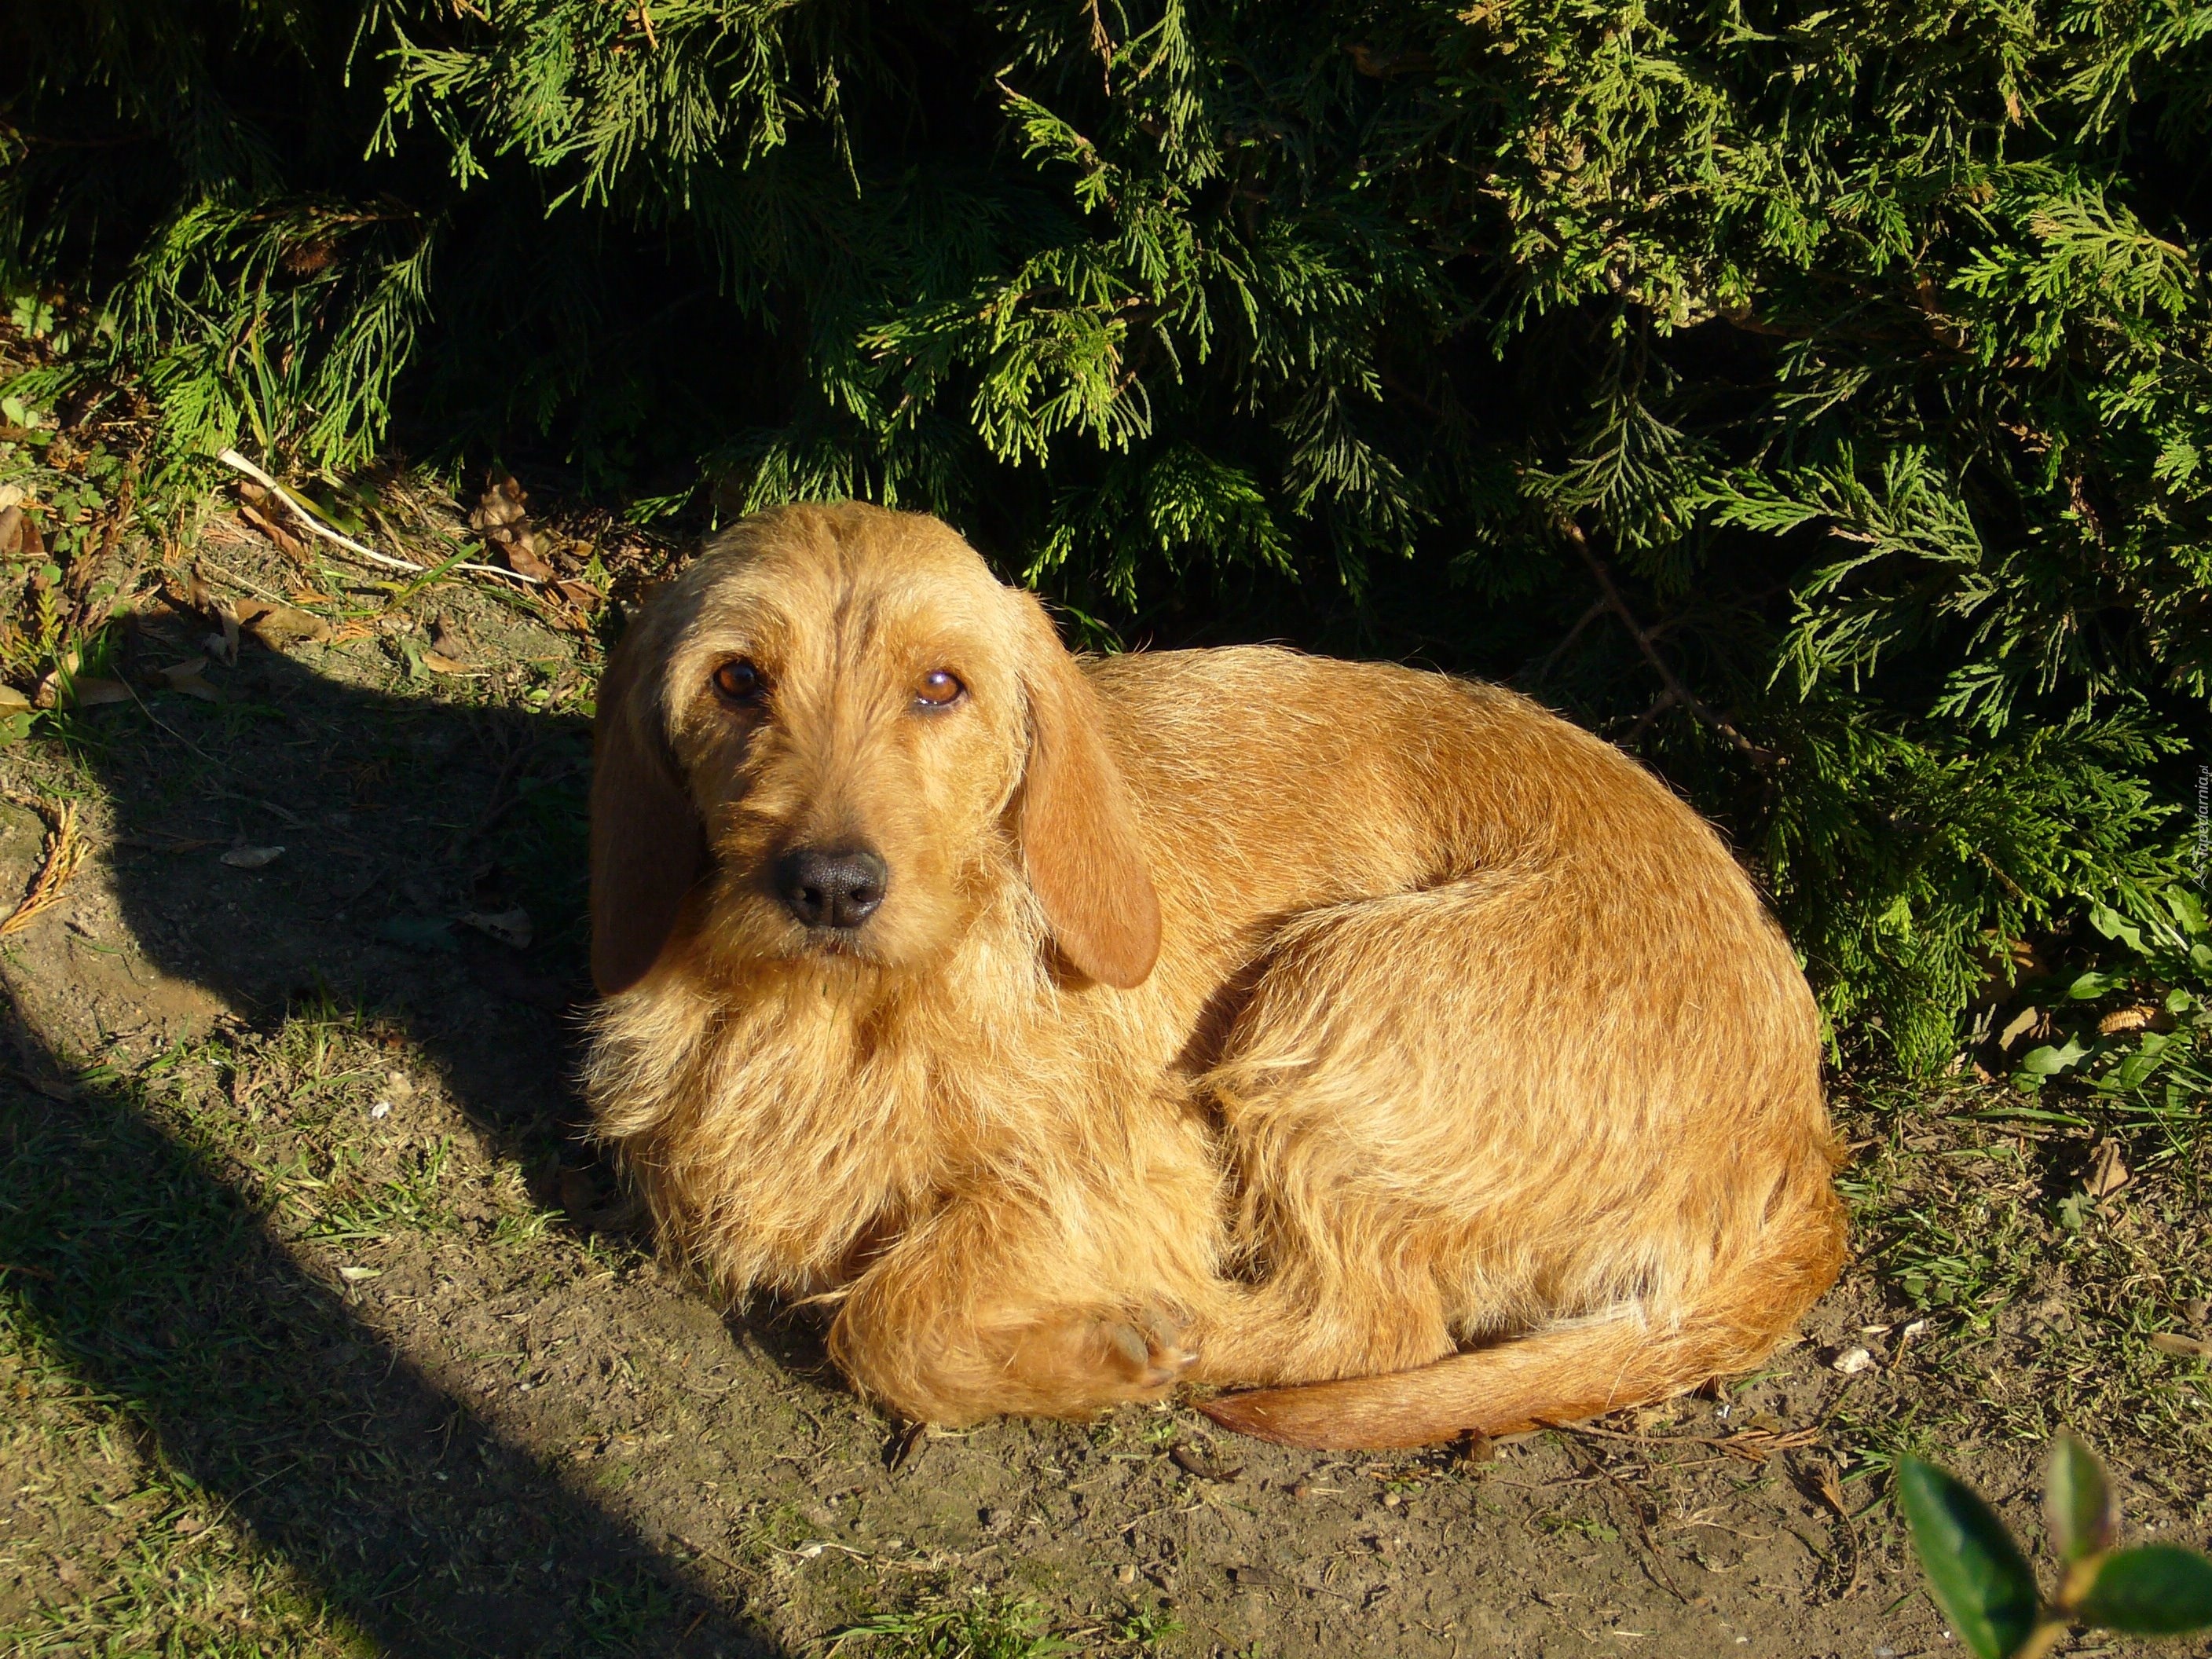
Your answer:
[0,0,2212,1066]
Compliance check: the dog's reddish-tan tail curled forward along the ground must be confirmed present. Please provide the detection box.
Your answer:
[1199,1199,1843,1451]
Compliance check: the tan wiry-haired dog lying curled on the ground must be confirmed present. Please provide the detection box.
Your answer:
[591,504,1843,1447]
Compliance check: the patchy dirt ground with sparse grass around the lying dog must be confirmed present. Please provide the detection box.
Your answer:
[0,520,2212,1659]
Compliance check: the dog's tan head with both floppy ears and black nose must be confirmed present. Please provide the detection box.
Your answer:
[591,502,1159,995]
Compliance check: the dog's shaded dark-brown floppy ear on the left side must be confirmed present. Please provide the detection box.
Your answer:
[591,626,708,995]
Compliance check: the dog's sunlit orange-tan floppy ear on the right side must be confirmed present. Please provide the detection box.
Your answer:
[1016,593,1159,991]
